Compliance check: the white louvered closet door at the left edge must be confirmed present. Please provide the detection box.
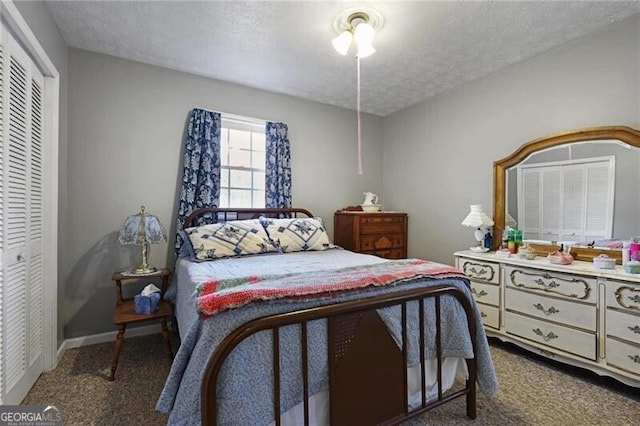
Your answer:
[0,25,44,404]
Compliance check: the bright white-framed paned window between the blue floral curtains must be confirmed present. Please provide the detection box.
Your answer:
[220,115,266,208]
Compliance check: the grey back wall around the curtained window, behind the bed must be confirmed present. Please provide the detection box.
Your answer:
[61,49,382,338]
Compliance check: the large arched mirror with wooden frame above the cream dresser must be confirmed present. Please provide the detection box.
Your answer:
[493,126,640,260]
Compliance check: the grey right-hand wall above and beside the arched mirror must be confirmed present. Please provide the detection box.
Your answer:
[383,17,640,264]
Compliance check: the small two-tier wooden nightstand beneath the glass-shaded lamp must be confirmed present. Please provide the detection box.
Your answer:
[110,268,173,380]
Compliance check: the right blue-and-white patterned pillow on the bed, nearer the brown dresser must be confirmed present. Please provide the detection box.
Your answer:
[260,217,334,253]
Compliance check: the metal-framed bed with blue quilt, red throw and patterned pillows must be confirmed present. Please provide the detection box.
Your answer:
[156,208,498,426]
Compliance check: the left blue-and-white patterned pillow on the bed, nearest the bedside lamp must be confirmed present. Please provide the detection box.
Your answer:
[183,219,278,261]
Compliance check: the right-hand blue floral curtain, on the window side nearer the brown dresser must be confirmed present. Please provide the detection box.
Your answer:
[265,121,291,208]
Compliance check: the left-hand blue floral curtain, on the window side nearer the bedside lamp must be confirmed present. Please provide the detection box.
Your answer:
[176,109,221,246]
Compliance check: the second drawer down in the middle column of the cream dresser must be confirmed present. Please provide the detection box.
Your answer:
[505,288,598,332]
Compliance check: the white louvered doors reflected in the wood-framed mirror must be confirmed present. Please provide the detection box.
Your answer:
[518,156,615,243]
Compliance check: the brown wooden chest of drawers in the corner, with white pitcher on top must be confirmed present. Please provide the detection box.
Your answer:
[333,210,408,259]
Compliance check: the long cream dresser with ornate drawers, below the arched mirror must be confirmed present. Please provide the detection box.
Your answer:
[454,251,640,387]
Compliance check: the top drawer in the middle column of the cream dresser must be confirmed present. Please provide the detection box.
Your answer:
[504,267,598,304]
